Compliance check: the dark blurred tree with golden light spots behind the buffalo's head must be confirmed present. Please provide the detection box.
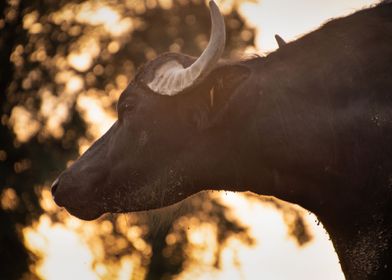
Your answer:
[0,0,312,279]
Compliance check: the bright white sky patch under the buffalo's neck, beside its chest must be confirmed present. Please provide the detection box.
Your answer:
[216,192,344,280]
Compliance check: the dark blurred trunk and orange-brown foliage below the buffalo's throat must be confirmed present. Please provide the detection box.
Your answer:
[141,192,254,279]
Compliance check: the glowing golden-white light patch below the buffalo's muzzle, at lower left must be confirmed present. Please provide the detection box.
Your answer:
[23,188,148,280]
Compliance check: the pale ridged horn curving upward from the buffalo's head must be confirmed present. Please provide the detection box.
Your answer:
[148,0,226,95]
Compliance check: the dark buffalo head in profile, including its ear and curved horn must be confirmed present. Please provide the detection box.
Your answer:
[52,1,249,220]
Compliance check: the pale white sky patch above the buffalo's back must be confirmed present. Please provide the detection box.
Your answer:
[239,0,380,53]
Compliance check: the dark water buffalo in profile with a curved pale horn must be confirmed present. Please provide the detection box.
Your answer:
[52,2,392,279]
